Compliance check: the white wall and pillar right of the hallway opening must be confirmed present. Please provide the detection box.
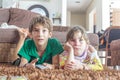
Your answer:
[86,0,110,32]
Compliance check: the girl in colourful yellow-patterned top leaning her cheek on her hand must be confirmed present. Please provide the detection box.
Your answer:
[60,26,103,70]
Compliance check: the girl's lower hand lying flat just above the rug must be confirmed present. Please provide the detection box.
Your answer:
[64,62,84,70]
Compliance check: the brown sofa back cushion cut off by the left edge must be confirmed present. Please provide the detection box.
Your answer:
[0,8,9,25]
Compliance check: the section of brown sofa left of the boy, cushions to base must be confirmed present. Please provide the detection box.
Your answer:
[0,8,40,62]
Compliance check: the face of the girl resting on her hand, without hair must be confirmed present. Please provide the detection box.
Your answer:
[69,31,87,56]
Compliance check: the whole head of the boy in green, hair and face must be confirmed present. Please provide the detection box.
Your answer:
[29,16,53,47]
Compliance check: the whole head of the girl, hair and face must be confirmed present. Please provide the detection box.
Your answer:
[66,26,89,56]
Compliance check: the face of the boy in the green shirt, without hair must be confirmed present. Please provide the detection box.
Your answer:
[32,24,52,46]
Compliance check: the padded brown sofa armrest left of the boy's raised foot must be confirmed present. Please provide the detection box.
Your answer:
[0,28,19,43]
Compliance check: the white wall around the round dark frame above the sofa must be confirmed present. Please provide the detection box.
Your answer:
[19,0,62,25]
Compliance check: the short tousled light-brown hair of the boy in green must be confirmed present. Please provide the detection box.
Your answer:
[29,16,53,33]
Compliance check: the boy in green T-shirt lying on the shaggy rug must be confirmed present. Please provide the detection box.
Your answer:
[16,16,63,69]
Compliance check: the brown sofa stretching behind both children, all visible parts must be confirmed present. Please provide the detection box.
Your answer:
[0,8,99,62]
